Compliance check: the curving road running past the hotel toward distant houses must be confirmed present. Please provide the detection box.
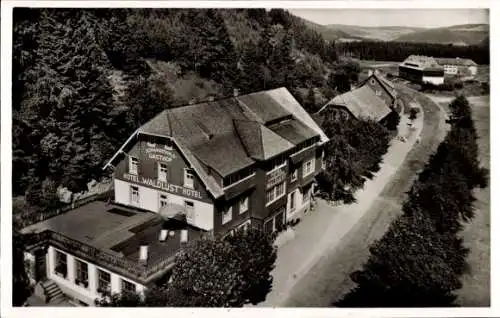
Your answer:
[282,86,447,307]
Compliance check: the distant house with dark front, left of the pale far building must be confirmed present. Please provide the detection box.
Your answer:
[399,55,444,85]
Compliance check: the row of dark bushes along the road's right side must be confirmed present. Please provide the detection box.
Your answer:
[335,96,487,307]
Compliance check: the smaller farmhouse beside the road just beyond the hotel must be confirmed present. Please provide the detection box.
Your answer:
[314,71,397,124]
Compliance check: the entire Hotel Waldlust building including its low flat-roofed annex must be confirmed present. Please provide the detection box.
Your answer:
[23,88,328,305]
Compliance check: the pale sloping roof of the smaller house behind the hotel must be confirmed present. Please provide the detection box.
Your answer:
[318,85,392,121]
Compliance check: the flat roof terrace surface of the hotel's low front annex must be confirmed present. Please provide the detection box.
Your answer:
[22,201,204,265]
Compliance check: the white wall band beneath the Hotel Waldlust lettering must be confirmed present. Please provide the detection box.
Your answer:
[115,179,214,231]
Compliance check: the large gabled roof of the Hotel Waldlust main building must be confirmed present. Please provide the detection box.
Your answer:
[106,88,328,198]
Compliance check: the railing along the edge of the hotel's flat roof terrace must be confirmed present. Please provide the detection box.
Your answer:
[28,230,175,283]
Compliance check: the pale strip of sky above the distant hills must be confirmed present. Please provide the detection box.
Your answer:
[288,9,489,28]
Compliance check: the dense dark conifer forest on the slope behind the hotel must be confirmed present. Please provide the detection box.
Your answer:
[12,8,342,221]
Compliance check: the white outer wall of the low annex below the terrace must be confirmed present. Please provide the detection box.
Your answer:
[47,246,145,306]
